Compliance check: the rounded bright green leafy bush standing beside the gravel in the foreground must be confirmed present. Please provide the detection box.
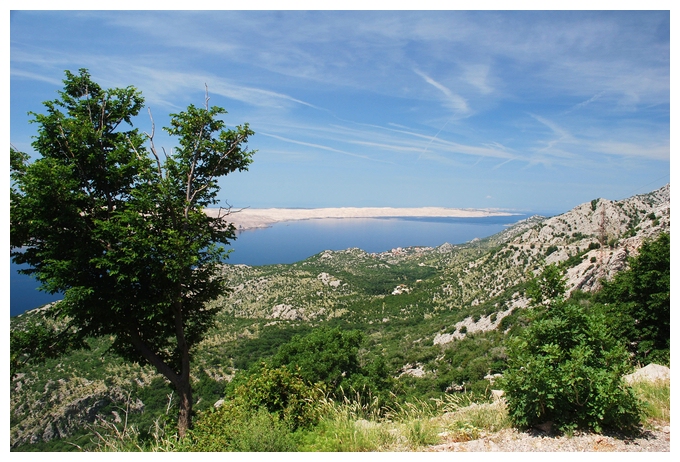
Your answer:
[501,302,640,432]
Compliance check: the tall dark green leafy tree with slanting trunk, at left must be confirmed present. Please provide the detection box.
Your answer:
[10,69,254,437]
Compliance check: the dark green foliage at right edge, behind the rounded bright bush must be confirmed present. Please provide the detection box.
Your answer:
[597,234,671,365]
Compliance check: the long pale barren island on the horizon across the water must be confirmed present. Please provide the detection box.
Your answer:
[206,207,517,229]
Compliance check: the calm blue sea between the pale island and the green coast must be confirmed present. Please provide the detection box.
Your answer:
[10,215,528,316]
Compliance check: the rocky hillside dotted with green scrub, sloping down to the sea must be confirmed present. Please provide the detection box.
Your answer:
[10,185,670,448]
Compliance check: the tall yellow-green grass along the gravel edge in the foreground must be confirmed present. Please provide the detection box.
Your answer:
[62,380,670,452]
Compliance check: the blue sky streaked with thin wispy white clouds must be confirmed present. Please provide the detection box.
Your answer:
[10,7,670,214]
